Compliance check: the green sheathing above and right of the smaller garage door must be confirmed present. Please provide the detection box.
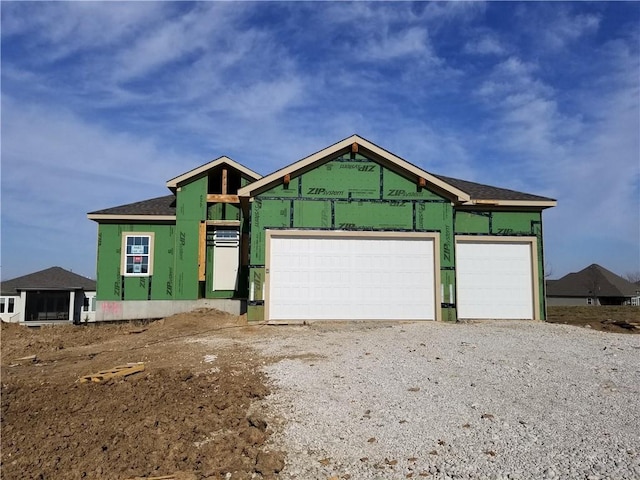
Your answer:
[455,210,546,320]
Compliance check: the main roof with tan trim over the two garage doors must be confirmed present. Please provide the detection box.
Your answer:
[238,135,556,208]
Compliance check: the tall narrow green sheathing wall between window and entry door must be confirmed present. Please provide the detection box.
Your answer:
[174,177,208,300]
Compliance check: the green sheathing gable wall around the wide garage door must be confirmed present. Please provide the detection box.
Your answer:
[247,154,456,321]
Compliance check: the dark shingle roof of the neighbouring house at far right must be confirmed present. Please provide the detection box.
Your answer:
[547,263,640,297]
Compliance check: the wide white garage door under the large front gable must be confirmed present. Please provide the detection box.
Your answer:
[266,231,436,320]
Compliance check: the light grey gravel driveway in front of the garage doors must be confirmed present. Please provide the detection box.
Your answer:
[252,321,640,480]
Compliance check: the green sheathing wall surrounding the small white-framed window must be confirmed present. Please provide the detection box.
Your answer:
[96,224,175,300]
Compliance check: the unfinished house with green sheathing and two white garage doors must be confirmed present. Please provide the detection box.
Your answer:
[88,135,556,321]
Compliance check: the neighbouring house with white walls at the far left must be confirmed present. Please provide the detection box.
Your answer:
[0,267,96,326]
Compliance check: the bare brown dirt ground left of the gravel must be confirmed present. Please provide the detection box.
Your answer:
[1,310,284,480]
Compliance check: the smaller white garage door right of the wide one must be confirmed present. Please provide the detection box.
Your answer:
[456,241,534,319]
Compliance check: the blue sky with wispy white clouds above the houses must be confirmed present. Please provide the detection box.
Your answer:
[1,1,640,279]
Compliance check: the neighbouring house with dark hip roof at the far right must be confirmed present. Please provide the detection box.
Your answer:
[547,263,640,306]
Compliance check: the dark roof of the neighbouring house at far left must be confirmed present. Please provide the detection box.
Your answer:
[0,267,96,295]
